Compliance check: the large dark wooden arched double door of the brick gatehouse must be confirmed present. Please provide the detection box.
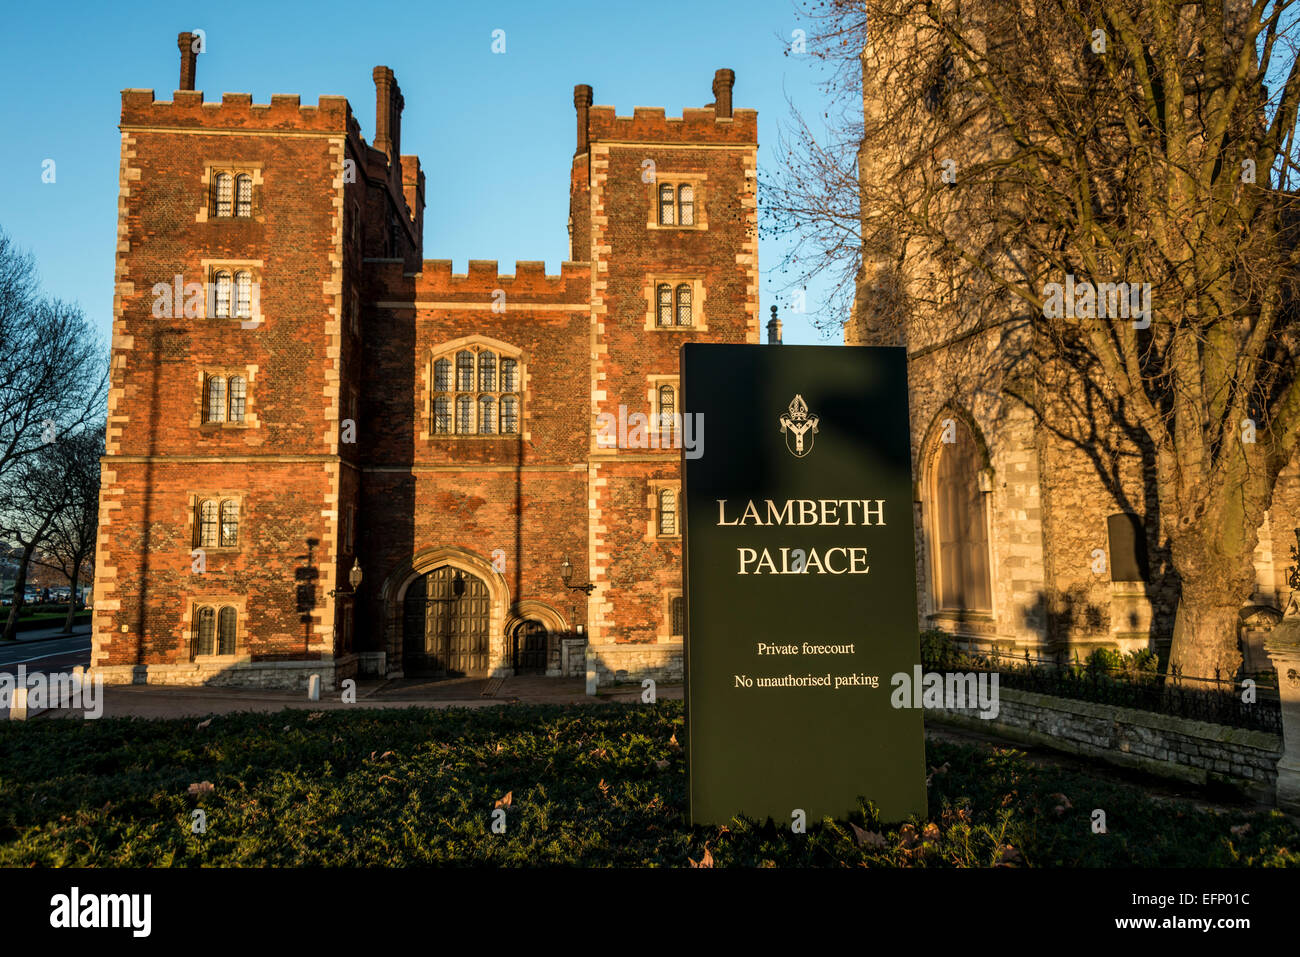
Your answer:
[402,566,491,676]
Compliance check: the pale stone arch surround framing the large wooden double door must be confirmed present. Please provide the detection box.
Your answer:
[380,546,511,677]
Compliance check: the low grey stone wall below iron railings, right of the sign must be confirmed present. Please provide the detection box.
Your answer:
[926,688,1282,802]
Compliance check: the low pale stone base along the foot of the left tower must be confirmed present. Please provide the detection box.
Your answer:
[86,654,359,692]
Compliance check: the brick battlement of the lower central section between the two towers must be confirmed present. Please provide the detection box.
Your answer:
[374,259,592,304]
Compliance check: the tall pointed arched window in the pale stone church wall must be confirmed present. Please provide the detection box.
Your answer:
[931,417,993,612]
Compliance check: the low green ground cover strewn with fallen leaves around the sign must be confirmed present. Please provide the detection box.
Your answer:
[0,702,1300,867]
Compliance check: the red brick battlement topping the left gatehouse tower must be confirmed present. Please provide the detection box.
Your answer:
[122,90,360,134]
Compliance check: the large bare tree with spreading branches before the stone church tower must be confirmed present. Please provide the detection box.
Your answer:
[767,0,1300,675]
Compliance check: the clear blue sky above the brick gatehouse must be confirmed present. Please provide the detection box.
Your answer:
[0,0,840,343]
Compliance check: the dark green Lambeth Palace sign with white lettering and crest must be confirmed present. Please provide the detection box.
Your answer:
[681,345,926,823]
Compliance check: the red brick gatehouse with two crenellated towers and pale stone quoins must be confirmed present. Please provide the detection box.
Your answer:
[91,34,759,689]
